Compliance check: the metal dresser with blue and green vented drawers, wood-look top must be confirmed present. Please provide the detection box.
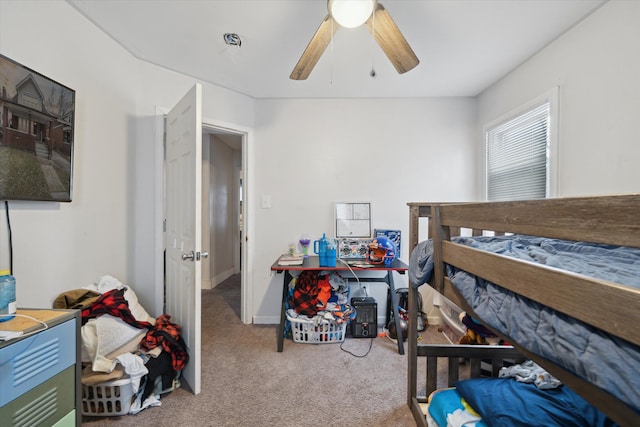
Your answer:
[0,309,82,427]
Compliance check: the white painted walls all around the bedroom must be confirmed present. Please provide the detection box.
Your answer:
[0,0,640,323]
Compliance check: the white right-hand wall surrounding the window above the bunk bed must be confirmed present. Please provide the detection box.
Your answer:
[477,1,640,196]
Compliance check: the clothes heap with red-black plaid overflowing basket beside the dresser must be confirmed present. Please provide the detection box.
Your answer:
[53,275,189,414]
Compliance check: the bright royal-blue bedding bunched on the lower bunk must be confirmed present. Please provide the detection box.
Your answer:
[456,378,616,427]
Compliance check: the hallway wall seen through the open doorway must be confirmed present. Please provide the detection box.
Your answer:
[202,125,245,309]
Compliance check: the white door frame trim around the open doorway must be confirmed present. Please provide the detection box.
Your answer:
[154,107,254,324]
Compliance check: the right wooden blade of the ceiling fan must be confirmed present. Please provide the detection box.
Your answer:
[367,3,420,74]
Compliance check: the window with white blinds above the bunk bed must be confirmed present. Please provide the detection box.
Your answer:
[485,91,557,201]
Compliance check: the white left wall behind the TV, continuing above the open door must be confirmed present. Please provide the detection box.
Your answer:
[0,0,254,315]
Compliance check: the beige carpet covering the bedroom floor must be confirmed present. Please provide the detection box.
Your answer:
[83,276,444,427]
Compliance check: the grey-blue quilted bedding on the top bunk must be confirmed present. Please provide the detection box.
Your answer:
[409,236,640,414]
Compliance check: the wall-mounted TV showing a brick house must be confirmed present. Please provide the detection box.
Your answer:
[0,54,76,202]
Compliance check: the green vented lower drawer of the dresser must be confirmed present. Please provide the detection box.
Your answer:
[0,366,76,427]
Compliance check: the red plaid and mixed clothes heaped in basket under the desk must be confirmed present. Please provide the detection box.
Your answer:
[287,270,356,324]
